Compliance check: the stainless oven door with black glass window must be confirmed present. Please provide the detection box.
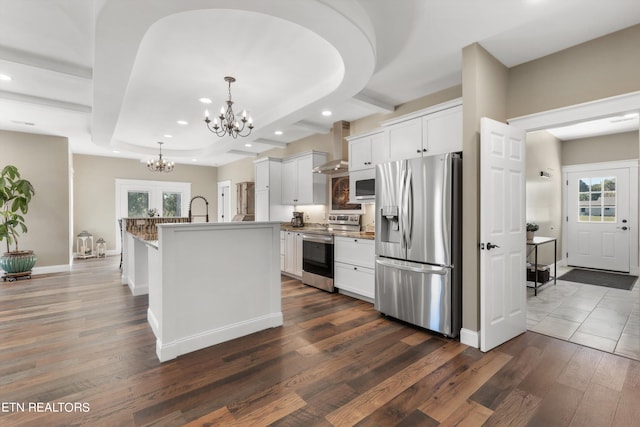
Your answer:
[302,234,334,292]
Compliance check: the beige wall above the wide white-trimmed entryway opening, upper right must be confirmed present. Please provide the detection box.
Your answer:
[508,25,640,117]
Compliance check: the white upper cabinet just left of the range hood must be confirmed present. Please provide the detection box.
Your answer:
[282,151,327,205]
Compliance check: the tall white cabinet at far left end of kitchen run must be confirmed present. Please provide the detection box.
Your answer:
[254,157,293,221]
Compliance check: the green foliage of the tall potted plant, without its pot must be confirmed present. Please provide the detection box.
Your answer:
[0,165,35,252]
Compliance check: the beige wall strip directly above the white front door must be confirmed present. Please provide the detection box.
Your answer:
[562,131,640,165]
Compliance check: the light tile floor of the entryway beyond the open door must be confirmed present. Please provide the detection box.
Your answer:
[527,266,640,360]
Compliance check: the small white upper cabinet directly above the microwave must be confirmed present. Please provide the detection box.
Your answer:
[347,129,389,172]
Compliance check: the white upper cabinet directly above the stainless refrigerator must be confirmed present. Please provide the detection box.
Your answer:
[383,99,462,160]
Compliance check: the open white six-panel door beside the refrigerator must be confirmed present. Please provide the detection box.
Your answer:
[480,117,527,351]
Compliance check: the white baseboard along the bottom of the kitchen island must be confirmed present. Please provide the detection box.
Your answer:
[152,312,283,362]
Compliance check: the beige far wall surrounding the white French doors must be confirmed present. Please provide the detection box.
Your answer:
[73,154,217,250]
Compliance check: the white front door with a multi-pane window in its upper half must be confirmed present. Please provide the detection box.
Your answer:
[566,168,631,273]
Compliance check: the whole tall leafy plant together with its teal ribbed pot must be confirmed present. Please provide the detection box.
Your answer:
[0,165,36,280]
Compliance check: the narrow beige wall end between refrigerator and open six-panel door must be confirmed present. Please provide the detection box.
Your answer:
[462,43,508,331]
